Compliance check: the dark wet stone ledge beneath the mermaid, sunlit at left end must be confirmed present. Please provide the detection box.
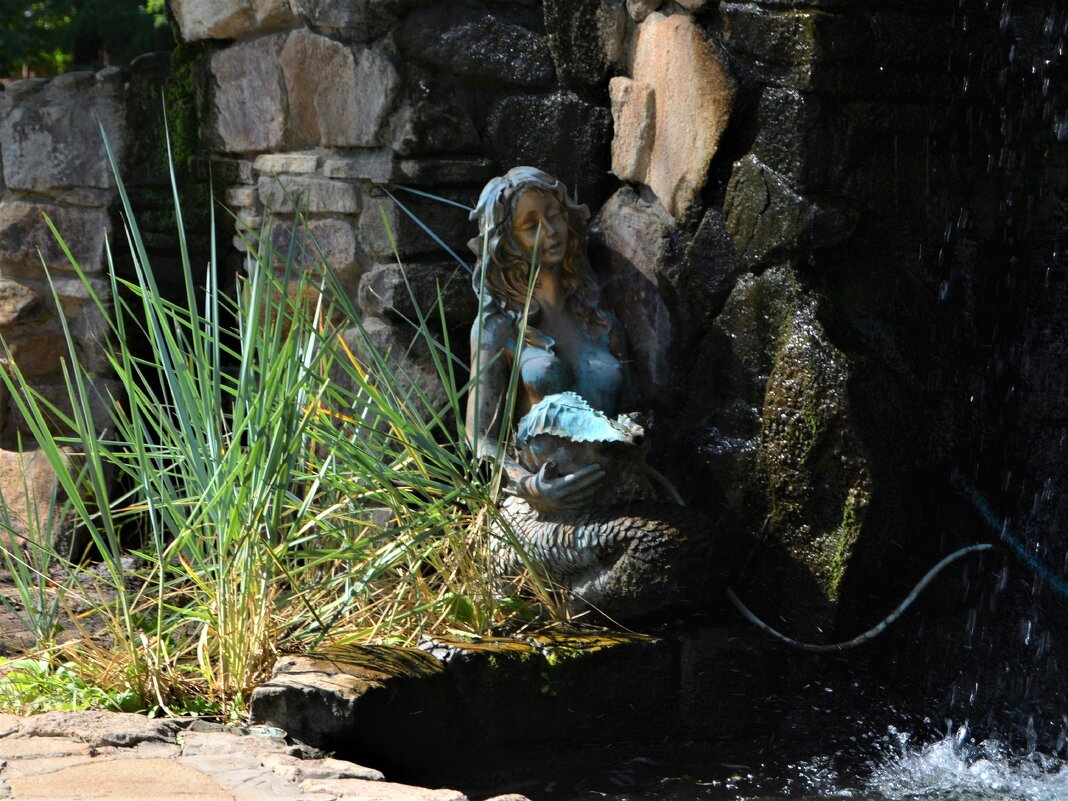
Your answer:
[251,629,791,797]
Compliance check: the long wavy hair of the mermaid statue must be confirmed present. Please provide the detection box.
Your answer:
[468,167,609,347]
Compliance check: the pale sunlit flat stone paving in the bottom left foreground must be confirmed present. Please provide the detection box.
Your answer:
[0,710,480,801]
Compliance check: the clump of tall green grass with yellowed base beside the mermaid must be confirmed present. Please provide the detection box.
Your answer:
[0,135,538,712]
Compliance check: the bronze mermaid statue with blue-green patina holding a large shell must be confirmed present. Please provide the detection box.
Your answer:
[467,167,720,621]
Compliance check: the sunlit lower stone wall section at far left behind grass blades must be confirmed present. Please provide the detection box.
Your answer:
[0,68,128,449]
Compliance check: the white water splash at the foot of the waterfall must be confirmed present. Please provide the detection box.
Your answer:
[867,727,1068,801]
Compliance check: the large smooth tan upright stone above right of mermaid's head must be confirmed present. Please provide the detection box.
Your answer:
[613,13,737,219]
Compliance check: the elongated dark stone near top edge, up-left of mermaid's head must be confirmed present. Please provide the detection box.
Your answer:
[397,3,553,87]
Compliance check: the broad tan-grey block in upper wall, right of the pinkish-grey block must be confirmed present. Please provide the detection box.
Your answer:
[281,30,401,147]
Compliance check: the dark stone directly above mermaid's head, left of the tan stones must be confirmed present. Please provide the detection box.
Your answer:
[488,92,612,206]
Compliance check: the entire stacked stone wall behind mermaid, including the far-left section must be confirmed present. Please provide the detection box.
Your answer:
[0,0,1068,662]
